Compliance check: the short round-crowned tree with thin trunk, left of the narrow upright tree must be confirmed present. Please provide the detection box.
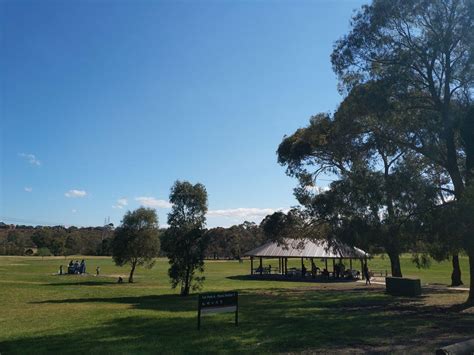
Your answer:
[112,207,160,283]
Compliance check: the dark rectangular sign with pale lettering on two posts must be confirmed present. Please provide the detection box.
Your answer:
[198,292,239,330]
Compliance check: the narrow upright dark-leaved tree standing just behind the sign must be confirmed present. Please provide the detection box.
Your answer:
[161,181,208,296]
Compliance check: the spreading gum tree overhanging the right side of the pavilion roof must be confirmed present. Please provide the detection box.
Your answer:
[278,110,435,277]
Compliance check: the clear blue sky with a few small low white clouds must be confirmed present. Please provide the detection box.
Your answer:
[0,0,363,227]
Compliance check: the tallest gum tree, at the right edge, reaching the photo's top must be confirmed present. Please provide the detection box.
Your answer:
[332,0,474,303]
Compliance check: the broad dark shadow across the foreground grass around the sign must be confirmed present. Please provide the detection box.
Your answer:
[6,289,474,353]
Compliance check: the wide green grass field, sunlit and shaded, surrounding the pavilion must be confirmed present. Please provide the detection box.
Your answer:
[0,257,474,355]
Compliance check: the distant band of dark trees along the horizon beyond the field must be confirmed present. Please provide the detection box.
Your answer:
[0,222,265,259]
